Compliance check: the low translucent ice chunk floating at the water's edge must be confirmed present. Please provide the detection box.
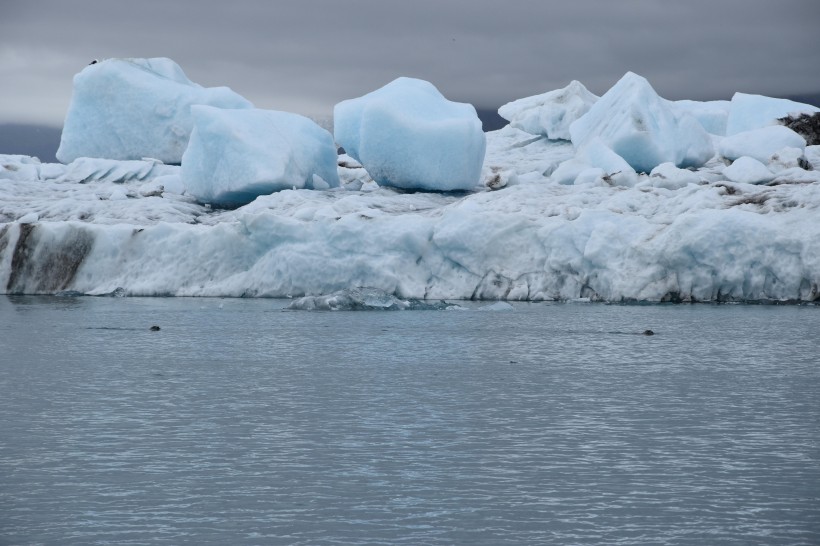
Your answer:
[286,288,458,311]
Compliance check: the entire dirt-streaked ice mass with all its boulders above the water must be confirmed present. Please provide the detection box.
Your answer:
[0,59,820,302]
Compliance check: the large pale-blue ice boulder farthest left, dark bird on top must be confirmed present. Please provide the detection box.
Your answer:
[57,58,253,164]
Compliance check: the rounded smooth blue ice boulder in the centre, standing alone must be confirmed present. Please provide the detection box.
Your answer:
[333,78,486,191]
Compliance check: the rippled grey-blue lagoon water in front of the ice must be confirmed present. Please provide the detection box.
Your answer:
[0,296,820,545]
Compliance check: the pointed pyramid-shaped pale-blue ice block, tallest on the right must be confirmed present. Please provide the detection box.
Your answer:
[569,72,714,172]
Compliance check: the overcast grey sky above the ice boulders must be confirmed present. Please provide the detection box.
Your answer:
[0,0,820,125]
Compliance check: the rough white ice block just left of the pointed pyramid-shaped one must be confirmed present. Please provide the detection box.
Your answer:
[498,80,598,140]
